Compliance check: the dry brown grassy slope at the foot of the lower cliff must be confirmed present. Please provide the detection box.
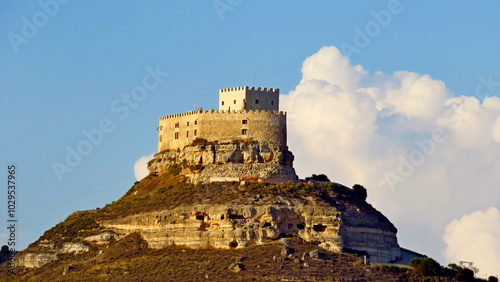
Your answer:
[5,234,409,281]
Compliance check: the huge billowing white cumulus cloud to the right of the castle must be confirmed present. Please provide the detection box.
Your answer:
[280,47,500,267]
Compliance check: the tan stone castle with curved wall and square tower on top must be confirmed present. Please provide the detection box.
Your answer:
[158,86,286,152]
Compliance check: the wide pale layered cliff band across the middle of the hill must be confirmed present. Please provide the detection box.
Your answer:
[101,197,400,262]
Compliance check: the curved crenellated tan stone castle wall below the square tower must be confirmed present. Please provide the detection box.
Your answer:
[158,110,287,152]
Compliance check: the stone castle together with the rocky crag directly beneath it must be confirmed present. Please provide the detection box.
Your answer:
[148,86,297,182]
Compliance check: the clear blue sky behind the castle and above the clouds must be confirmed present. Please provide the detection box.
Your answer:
[0,0,500,276]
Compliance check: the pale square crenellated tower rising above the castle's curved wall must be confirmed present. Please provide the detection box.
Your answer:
[219,86,280,111]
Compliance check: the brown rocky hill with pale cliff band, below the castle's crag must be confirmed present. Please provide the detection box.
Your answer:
[0,173,484,281]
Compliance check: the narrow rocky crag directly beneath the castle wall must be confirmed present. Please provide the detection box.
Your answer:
[148,142,297,182]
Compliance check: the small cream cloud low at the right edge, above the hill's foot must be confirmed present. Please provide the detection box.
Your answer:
[443,207,500,275]
